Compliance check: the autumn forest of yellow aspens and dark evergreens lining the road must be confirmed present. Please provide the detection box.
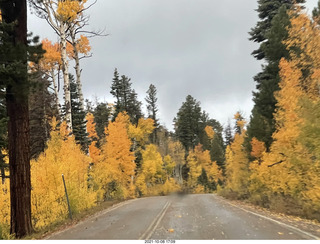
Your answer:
[0,0,320,239]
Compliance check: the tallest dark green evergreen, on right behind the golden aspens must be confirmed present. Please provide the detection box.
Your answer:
[247,0,305,151]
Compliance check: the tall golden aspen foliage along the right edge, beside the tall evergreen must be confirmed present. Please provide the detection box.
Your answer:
[245,9,320,215]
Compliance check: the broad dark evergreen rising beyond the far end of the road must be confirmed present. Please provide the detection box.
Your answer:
[174,95,202,152]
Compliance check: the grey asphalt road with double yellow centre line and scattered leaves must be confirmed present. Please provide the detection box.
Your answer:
[48,194,319,240]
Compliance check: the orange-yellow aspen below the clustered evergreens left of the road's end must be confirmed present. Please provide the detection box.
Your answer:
[95,113,136,198]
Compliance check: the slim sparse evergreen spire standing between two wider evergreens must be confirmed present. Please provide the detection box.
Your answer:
[145,84,159,144]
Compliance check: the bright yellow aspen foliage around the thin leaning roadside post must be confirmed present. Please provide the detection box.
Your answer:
[31,120,96,229]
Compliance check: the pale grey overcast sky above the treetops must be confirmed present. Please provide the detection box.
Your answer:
[28,0,317,130]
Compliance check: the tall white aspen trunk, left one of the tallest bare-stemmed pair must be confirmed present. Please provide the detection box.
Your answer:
[60,23,72,132]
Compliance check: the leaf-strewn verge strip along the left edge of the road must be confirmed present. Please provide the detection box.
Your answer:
[23,200,122,240]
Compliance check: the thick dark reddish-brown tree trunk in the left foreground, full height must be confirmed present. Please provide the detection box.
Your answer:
[0,0,32,238]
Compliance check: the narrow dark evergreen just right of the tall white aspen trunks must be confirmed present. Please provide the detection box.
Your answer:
[69,75,89,152]
